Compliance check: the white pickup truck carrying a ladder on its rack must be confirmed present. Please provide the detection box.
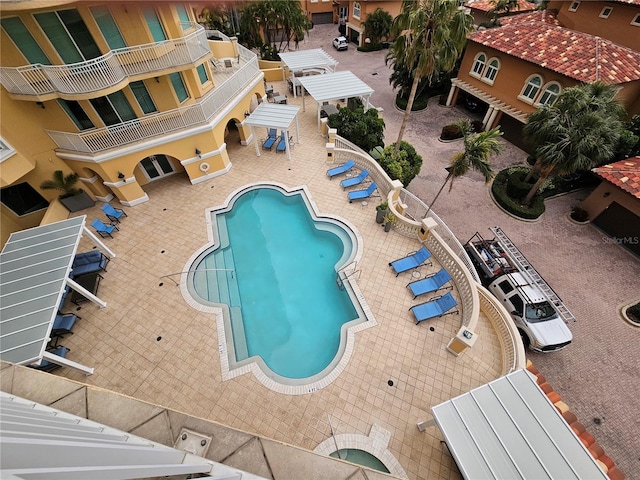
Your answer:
[464,227,575,352]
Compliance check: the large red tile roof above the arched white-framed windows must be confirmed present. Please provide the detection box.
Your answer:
[469,11,640,85]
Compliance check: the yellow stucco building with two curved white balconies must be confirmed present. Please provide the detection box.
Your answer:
[0,0,265,248]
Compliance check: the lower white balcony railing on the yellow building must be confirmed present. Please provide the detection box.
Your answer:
[47,50,260,154]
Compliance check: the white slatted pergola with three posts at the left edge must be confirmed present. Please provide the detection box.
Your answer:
[0,215,115,374]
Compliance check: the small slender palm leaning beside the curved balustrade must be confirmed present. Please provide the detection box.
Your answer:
[424,120,503,217]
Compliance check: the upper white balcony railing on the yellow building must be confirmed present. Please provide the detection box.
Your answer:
[0,23,211,96]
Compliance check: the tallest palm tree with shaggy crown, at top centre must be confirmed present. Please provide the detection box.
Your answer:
[387,0,473,153]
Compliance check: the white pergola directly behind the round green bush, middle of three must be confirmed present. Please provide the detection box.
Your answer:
[298,70,374,130]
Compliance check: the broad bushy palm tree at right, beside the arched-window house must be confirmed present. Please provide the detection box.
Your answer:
[522,82,625,205]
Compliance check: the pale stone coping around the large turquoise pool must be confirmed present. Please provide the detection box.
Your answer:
[180,182,378,395]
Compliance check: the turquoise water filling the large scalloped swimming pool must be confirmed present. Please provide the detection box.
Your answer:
[192,187,359,379]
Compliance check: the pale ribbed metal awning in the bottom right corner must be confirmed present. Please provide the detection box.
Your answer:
[431,369,607,480]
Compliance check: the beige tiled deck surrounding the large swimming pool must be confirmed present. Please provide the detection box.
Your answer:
[43,85,501,480]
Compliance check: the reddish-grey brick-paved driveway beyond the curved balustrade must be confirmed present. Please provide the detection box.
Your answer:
[300,25,640,478]
